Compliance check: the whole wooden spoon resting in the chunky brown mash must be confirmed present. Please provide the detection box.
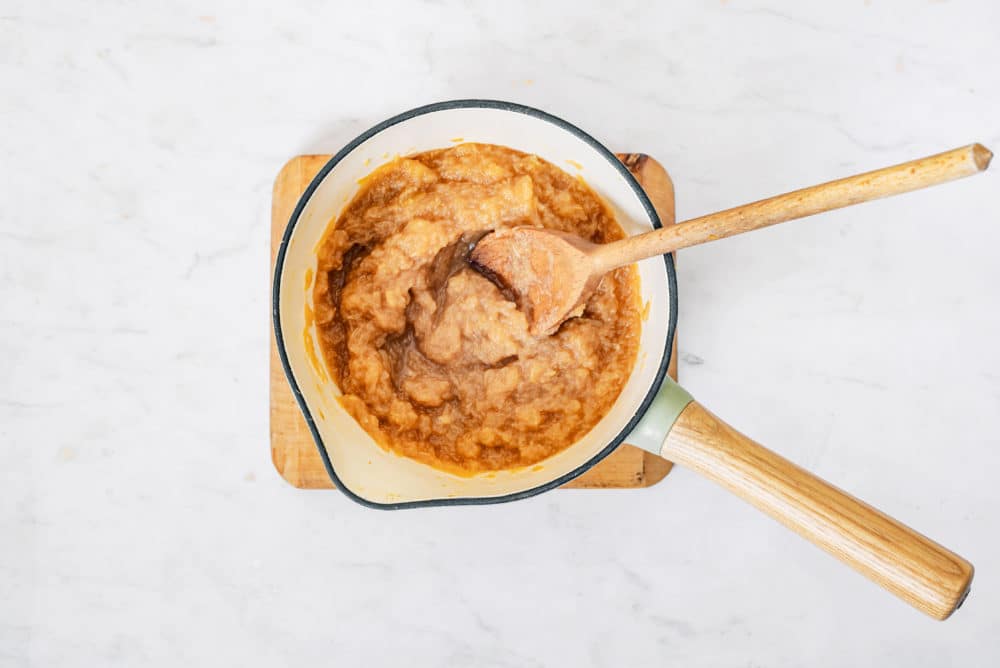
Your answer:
[469,144,993,336]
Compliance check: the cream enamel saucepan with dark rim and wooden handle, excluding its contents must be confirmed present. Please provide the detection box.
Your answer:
[273,100,973,619]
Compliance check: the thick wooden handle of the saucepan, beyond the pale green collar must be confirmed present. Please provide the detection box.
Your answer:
[662,401,973,619]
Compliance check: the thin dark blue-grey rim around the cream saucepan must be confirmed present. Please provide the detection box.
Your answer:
[271,99,677,510]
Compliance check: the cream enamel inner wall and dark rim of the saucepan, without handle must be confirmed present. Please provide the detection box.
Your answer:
[274,102,671,506]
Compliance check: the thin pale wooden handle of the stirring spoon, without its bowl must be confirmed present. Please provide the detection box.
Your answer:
[593,144,993,273]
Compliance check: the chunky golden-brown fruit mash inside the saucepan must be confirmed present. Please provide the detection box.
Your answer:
[313,144,640,474]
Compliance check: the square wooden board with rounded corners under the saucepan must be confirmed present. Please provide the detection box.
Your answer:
[271,153,677,489]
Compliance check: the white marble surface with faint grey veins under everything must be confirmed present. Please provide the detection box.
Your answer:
[0,0,1000,667]
